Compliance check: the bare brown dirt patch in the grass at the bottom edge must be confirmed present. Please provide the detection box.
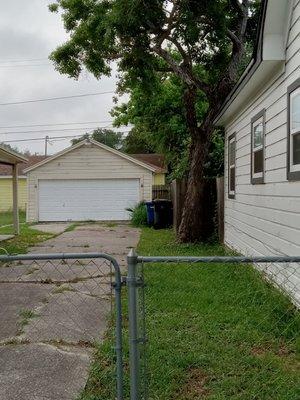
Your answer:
[176,368,210,400]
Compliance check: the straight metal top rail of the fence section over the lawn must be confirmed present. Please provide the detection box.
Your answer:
[137,256,300,264]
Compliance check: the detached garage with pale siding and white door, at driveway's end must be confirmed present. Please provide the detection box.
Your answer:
[25,140,155,222]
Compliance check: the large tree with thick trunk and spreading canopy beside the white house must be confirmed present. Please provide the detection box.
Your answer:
[50,0,259,242]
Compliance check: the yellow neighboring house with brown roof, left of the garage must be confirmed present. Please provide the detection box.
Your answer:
[0,155,45,212]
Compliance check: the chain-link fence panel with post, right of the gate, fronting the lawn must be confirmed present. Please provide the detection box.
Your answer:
[128,253,300,400]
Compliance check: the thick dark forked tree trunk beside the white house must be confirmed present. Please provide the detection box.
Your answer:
[177,48,243,243]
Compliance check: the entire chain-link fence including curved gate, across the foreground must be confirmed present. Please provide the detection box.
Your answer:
[0,251,300,400]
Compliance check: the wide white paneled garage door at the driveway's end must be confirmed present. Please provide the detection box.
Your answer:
[39,179,139,221]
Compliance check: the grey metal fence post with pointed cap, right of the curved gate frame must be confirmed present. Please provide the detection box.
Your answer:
[127,249,140,400]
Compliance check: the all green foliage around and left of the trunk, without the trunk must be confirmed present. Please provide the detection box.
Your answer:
[49,0,260,181]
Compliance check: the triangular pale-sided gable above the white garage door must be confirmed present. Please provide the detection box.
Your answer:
[24,139,155,173]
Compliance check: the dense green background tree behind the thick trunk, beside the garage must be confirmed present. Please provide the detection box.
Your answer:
[112,72,206,178]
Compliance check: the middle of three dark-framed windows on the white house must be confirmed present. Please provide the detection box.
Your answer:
[251,110,265,184]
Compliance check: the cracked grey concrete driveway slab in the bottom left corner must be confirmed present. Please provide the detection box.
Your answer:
[0,343,90,400]
